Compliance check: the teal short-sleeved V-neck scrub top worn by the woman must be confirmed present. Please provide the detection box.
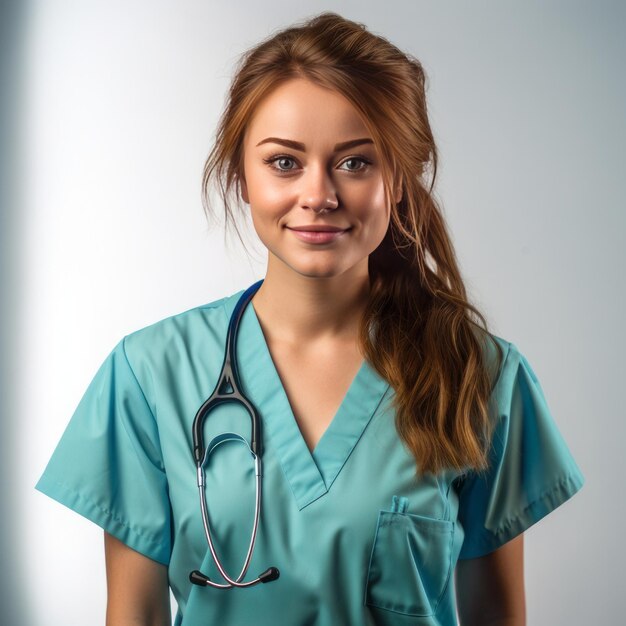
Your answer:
[37,290,584,626]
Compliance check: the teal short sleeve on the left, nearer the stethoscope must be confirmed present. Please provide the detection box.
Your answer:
[36,339,171,564]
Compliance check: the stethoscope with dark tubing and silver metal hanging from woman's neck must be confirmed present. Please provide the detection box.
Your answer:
[189,280,280,589]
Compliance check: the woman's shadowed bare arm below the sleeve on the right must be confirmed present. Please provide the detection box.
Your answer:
[455,534,526,626]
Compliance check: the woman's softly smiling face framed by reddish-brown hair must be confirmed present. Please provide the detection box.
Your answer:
[241,79,401,277]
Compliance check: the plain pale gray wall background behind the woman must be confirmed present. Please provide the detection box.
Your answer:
[0,0,626,626]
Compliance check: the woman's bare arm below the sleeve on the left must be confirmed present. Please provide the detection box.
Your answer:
[104,532,172,626]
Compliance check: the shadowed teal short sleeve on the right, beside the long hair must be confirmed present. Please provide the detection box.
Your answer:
[456,343,585,559]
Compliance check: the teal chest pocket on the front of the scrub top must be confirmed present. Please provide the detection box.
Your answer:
[365,496,454,619]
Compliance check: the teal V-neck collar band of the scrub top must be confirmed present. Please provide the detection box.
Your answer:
[224,290,389,510]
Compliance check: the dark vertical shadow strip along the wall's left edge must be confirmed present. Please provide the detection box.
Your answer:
[0,2,33,626]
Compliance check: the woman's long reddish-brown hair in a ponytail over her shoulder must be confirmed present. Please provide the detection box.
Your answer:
[202,12,502,474]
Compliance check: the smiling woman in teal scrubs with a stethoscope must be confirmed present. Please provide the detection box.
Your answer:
[38,13,584,626]
